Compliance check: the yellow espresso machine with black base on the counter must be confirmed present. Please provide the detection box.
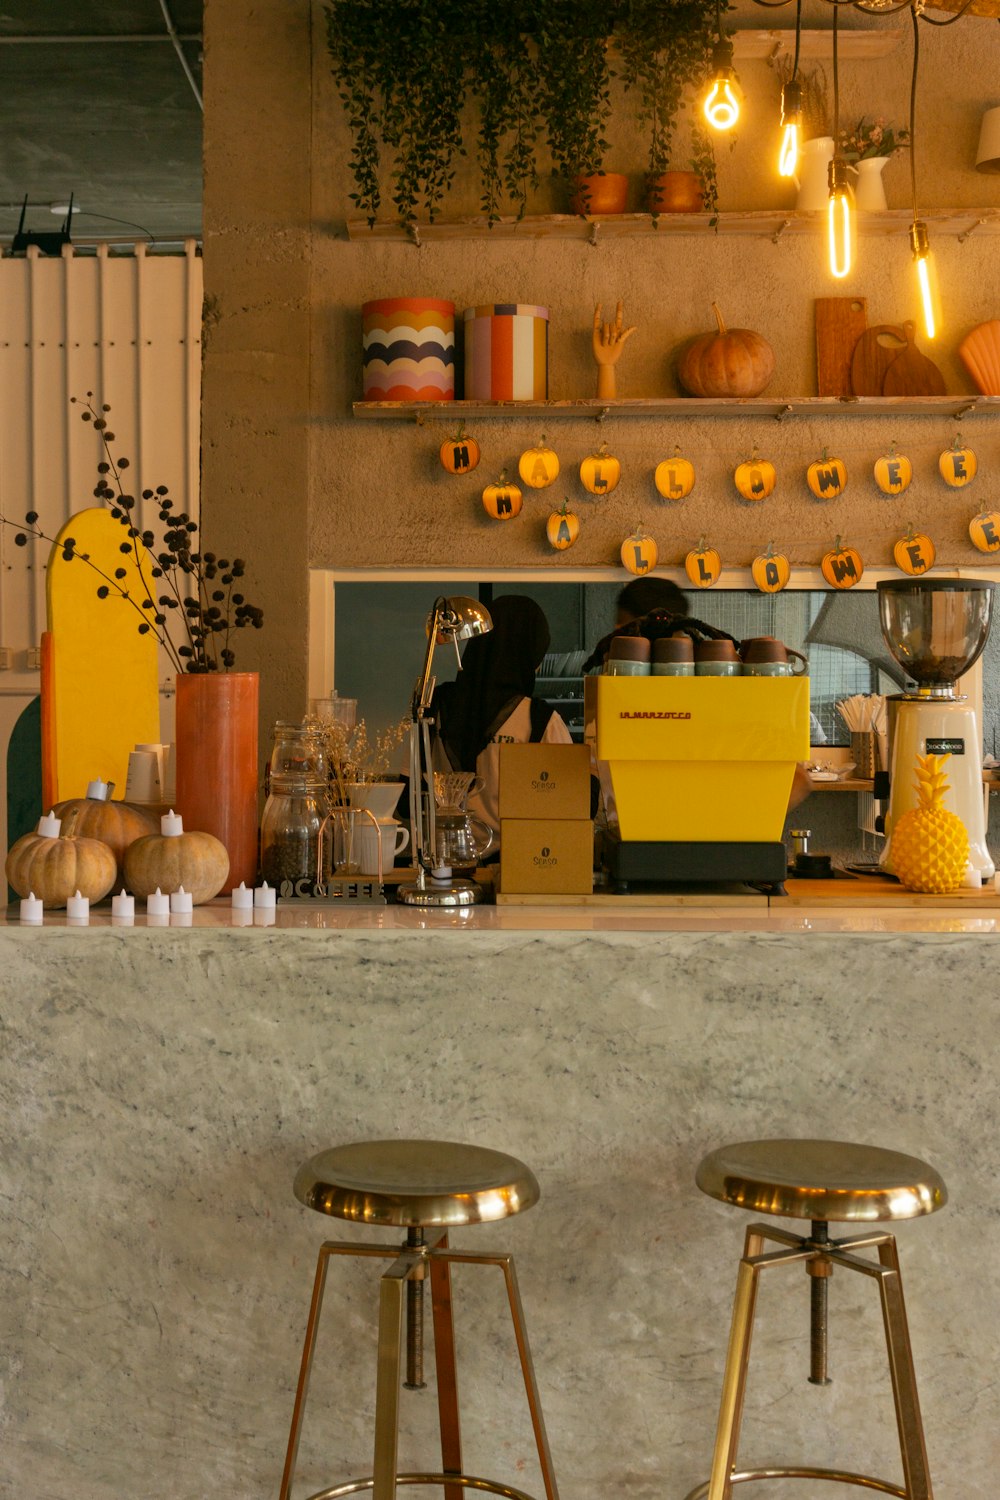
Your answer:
[585,677,810,893]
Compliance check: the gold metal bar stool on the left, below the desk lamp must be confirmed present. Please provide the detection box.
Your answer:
[280,1140,558,1500]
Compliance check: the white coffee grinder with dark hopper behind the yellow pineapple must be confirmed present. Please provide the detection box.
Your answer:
[877,578,996,881]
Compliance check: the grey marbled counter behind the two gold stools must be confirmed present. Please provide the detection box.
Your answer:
[0,906,1000,1500]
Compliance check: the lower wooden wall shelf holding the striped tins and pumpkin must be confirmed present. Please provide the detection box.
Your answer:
[352,396,1000,423]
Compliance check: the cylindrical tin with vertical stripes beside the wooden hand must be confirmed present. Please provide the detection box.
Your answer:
[465,302,549,401]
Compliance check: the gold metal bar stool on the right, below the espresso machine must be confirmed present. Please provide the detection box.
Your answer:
[687,1140,948,1500]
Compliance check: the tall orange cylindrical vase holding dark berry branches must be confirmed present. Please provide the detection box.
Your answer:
[175,672,259,891]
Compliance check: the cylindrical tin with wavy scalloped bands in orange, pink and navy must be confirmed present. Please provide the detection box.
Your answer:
[361,297,454,401]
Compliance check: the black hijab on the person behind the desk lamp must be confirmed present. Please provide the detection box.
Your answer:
[430,594,549,771]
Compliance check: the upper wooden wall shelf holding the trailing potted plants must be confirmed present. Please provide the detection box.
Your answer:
[348,209,1000,246]
